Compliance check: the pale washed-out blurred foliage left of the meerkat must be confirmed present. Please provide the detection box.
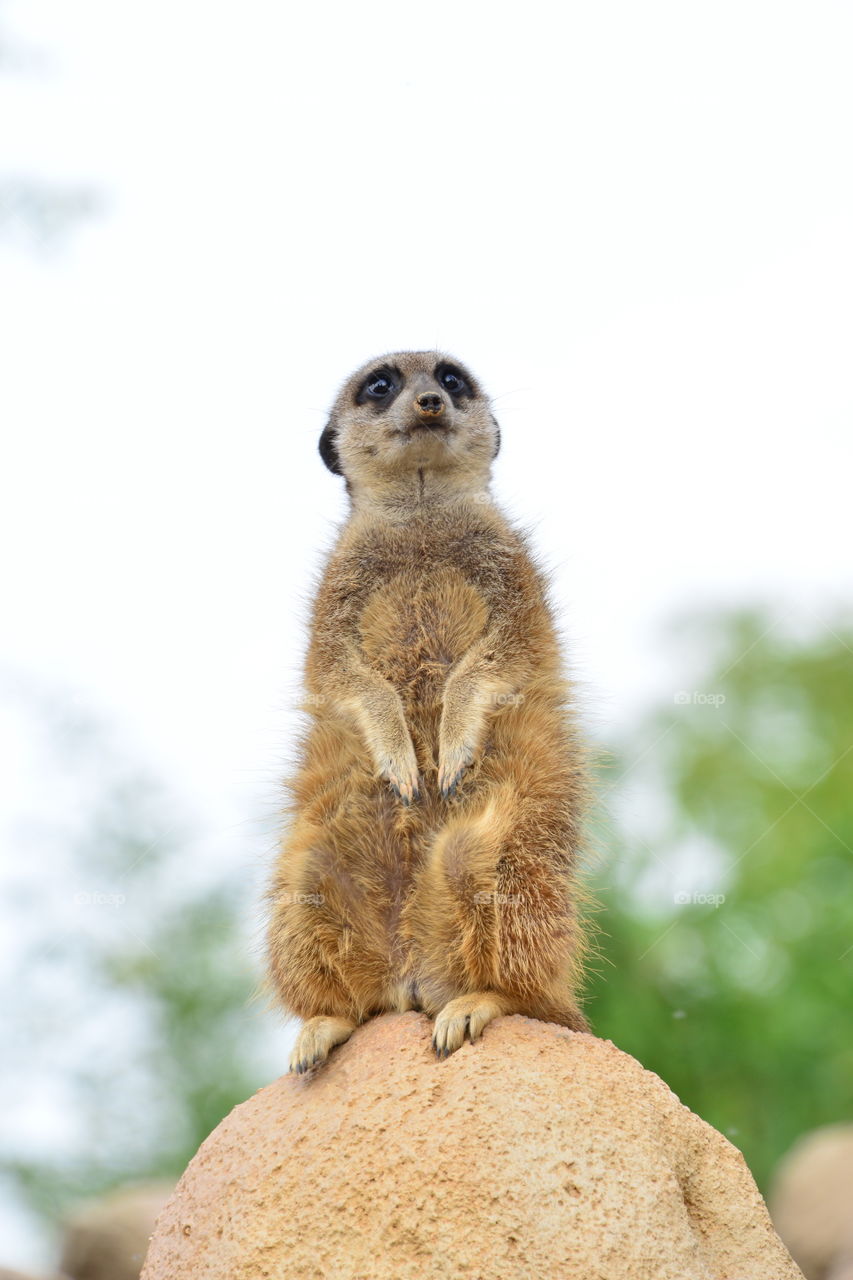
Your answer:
[0,689,268,1224]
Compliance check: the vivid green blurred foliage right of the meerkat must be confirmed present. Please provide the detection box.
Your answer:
[588,614,853,1185]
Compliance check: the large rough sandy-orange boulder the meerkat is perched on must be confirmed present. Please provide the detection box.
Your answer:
[142,1012,800,1280]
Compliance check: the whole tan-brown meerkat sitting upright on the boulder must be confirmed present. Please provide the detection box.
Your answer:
[268,352,588,1073]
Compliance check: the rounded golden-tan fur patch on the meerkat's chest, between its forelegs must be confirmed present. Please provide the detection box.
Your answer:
[360,566,488,707]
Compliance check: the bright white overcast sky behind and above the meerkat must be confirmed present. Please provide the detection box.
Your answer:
[0,0,853,1261]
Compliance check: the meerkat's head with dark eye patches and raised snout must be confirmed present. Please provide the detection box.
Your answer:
[320,351,501,504]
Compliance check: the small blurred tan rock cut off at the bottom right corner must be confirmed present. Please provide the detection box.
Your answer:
[768,1124,853,1280]
